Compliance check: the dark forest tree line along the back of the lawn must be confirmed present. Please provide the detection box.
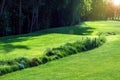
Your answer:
[0,0,120,36]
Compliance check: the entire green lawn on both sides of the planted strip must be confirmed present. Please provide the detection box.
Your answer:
[0,21,120,80]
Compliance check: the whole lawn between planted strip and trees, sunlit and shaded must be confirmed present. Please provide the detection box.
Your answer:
[0,21,120,60]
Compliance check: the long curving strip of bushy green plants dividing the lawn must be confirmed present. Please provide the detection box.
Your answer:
[0,36,106,75]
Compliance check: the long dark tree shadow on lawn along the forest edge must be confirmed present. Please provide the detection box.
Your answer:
[0,22,95,43]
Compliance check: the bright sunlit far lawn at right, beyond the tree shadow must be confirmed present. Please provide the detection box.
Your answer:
[85,21,120,35]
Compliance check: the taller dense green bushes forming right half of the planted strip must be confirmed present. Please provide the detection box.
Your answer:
[45,36,106,60]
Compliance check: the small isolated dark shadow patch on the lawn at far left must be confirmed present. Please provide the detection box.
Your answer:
[1,44,30,53]
